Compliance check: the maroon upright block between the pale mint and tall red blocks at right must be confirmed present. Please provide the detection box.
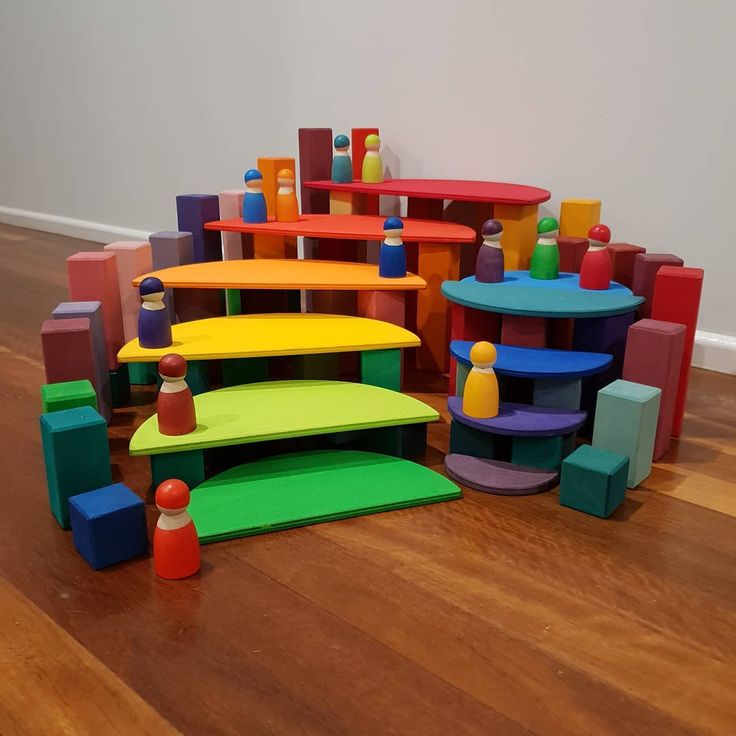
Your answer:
[622,319,686,460]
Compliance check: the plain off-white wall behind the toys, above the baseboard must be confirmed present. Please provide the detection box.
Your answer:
[0,0,736,344]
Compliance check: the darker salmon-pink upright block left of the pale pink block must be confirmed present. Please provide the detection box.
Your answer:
[66,252,125,371]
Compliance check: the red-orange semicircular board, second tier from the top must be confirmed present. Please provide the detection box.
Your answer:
[205,215,476,243]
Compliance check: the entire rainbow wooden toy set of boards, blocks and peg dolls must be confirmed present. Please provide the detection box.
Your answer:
[40,128,703,579]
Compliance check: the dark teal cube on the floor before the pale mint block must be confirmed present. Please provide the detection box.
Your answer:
[560,445,629,519]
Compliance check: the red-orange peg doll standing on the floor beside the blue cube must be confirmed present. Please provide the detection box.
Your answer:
[153,478,201,580]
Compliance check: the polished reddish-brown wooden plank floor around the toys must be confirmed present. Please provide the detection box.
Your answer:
[0,226,736,736]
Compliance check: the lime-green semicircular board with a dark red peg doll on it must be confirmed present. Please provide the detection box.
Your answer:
[130,381,439,455]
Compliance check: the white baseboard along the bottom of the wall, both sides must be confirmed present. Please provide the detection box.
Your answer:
[0,206,736,375]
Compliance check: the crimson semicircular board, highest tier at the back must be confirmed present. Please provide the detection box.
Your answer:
[305,179,551,205]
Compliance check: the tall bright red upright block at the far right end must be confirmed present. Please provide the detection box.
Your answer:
[652,264,703,437]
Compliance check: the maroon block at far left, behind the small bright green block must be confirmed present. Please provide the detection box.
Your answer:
[41,317,96,385]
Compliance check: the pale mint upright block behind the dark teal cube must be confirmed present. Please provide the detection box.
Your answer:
[593,380,662,488]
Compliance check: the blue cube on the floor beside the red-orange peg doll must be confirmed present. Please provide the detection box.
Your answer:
[69,483,148,570]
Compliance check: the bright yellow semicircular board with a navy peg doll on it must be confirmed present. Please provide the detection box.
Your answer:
[118,313,420,363]
